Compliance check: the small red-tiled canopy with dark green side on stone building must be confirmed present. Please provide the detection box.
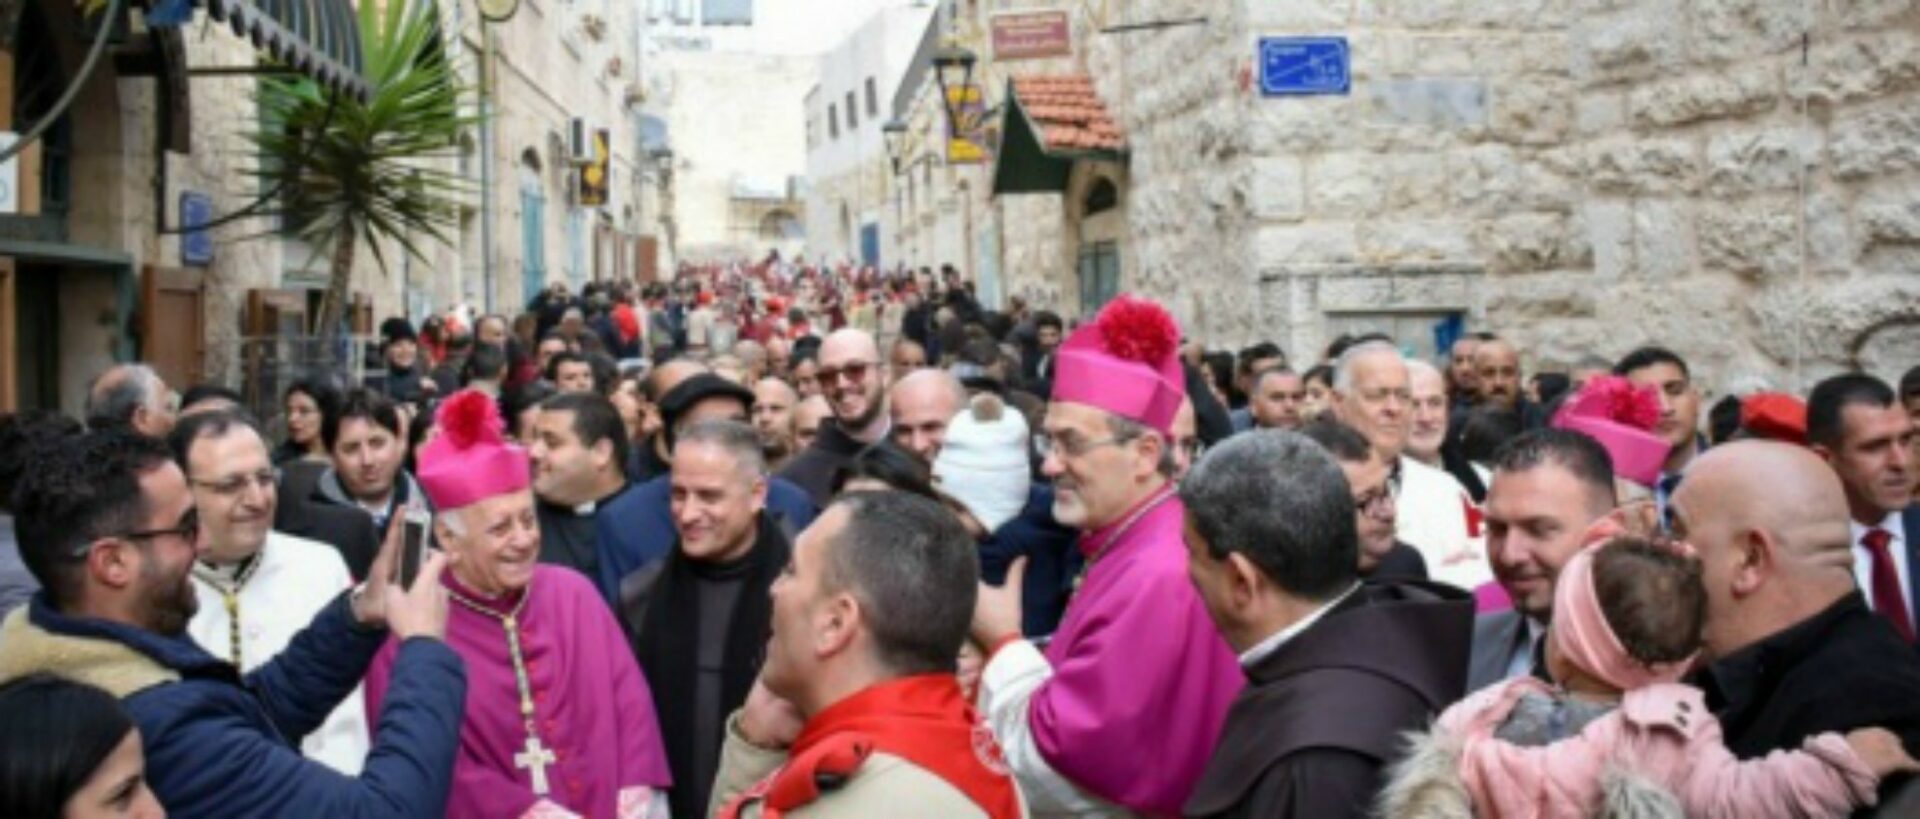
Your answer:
[993,75,1127,196]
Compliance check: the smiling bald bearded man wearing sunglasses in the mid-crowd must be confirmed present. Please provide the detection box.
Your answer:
[780,328,891,508]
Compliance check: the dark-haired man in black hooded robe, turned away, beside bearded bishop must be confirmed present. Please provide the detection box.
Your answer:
[1181,430,1473,819]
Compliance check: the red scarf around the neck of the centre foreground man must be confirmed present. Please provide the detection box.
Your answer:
[720,673,1020,819]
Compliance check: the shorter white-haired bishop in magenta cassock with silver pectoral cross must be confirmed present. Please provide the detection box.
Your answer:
[367,391,670,819]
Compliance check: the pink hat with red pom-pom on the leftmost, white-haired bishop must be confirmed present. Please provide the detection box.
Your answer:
[415,389,534,512]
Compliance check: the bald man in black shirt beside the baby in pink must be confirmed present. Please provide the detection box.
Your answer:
[1672,441,1920,771]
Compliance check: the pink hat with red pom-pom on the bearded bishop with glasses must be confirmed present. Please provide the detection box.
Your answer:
[1054,293,1187,435]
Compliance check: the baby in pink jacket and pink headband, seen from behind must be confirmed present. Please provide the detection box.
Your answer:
[1382,535,1920,819]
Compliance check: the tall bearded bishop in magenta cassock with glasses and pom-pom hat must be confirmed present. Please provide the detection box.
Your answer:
[973,295,1244,815]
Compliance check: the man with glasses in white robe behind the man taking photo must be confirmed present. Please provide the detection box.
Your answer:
[169,410,369,777]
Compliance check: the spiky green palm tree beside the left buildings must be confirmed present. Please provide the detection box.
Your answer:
[246,0,478,339]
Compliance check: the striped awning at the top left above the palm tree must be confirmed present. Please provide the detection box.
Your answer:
[194,0,369,100]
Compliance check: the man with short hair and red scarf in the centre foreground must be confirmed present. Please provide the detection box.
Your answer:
[712,493,1027,819]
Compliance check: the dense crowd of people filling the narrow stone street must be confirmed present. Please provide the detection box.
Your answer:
[0,257,1920,819]
